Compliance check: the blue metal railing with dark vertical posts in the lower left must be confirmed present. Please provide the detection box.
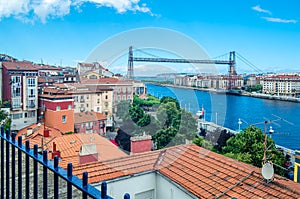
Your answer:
[0,126,130,199]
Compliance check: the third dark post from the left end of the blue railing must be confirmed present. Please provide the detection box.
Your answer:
[11,133,16,199]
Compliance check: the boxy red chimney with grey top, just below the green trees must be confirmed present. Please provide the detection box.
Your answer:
[130,133,152,154]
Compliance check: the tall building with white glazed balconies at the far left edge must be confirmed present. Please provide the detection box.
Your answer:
[0,61,39,131]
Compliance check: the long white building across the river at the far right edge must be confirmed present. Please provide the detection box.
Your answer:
[262,75,300,96]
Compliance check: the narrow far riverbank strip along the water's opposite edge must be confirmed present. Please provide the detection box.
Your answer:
[146,82,300,103]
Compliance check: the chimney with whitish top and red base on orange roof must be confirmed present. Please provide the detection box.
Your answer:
[79,143,98,164]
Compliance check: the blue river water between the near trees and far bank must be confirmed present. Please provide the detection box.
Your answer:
[146,84,300,149]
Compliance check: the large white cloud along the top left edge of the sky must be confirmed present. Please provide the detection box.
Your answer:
[0,0,153,23]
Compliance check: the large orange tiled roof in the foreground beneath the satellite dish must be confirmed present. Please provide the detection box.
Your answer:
[74,145,300,198]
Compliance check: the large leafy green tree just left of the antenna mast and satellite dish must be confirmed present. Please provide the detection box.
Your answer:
[222,126,285,175]
